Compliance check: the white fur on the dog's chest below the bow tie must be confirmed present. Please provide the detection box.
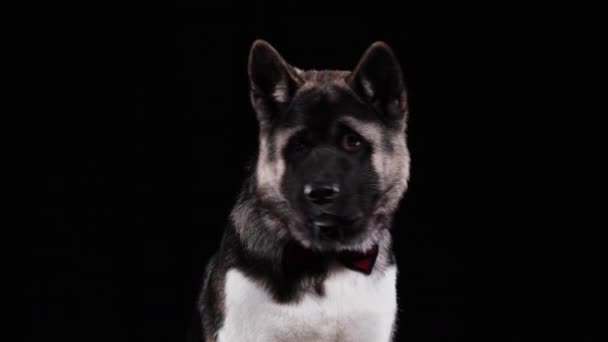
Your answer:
[218,266,397,342]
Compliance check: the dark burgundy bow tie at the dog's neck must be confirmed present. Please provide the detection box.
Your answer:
[284,242,378,275]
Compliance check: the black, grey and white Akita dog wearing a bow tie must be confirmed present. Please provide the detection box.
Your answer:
[198,40,410,342]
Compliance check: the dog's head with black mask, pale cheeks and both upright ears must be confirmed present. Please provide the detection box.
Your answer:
[242,40,410,250]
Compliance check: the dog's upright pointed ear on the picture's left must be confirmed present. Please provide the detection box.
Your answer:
[248,40,304,122]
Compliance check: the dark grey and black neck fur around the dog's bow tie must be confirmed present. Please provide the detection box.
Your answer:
[222,176,394,302]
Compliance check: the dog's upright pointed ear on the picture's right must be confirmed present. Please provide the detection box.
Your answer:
[346,42,407,120]
